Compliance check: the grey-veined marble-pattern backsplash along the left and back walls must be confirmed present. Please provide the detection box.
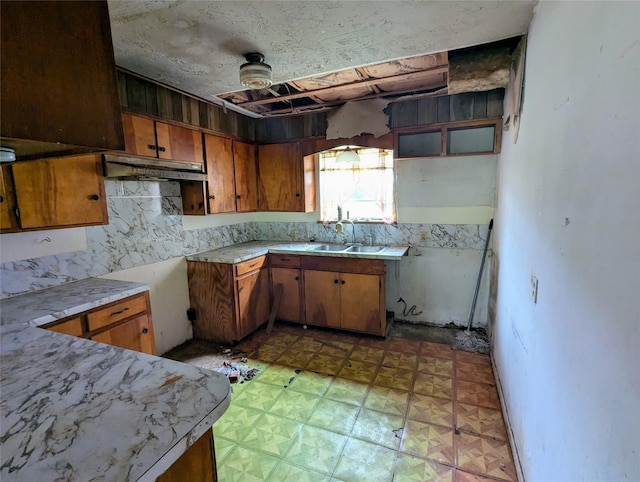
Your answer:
[0,180,487,298]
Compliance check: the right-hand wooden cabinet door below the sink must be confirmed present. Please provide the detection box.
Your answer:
[340,273,381,334]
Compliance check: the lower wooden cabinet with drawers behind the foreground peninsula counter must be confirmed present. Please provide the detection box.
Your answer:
[43,292,156,355]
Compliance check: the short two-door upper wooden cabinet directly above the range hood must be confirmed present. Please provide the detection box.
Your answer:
[122,114,204,170]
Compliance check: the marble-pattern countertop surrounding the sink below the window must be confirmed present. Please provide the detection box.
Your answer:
[187,241,409,264]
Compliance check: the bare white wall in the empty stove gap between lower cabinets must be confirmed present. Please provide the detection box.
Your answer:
[100,257,193,355]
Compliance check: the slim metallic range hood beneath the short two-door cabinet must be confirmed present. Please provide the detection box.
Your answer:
[102,154,207,181]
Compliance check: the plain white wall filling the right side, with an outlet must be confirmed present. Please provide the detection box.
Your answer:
[492,2,640,482]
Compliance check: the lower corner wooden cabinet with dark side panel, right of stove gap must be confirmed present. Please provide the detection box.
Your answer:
[187,256,270,344]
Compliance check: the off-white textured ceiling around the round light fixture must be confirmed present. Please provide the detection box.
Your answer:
[109,0,537,113]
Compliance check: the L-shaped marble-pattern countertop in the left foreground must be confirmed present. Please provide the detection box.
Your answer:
[0,279,230,482]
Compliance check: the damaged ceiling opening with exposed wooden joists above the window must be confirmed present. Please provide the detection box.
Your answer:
[217,37,521,117]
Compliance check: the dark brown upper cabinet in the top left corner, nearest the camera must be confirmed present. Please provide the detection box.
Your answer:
[0,1,124,160]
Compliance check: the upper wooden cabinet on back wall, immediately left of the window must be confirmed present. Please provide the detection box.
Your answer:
[258,142,316,212]
